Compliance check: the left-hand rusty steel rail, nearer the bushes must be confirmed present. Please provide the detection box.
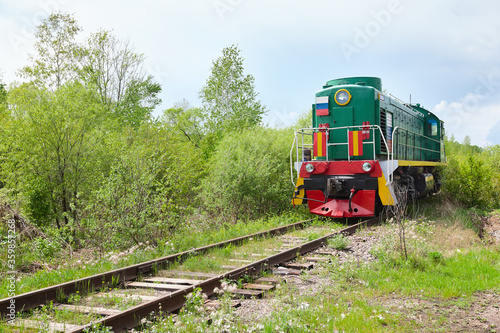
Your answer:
[0,220,311,320]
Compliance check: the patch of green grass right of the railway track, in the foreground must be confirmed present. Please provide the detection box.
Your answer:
[255,219,500,332]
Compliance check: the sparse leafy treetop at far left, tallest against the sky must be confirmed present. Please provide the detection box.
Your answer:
[19,12,81,91]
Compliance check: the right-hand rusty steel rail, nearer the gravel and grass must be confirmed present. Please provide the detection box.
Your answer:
[72,218,378,333]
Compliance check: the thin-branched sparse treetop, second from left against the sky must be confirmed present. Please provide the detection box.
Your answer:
[79,30,161,127]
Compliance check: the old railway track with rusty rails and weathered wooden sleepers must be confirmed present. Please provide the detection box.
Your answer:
[0,219,377,332]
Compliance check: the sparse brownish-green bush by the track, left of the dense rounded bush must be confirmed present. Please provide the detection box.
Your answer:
[82,147,166,250]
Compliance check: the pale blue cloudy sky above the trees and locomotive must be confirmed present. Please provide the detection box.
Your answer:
[0,0,500,146]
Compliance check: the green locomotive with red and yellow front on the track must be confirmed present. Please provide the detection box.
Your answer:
[290,77,446,217]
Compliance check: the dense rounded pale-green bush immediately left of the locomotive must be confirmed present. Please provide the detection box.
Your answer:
[202,127,293,221]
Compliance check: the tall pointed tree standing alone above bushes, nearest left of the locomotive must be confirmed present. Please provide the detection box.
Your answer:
[200,45,266,133]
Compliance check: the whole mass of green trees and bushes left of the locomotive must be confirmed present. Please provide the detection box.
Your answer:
[0,12,293,260]
